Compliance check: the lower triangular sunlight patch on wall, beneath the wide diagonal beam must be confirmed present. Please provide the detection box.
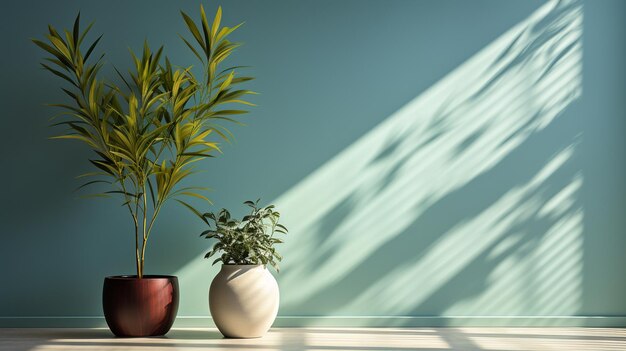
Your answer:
[338,146,582,316]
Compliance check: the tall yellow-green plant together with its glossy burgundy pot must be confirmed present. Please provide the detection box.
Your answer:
[33,6,252,336]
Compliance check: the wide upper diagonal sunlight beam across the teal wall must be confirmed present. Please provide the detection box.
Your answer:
[276,2,582,312]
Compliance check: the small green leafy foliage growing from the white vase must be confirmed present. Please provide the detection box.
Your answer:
[200,200,288,272]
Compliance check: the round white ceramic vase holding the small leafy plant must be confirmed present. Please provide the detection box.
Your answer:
[209,265,279,338]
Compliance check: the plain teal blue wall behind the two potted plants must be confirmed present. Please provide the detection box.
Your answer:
[0,0,626,326]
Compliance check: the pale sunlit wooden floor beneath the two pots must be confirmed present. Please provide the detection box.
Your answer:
[0,328,626,351]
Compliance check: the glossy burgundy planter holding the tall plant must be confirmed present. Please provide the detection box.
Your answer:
[102,275,178,336]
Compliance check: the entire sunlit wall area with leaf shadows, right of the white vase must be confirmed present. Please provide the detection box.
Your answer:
[276,1,583,322]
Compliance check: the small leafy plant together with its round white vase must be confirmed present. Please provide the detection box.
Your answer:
[201,200,287,338]
